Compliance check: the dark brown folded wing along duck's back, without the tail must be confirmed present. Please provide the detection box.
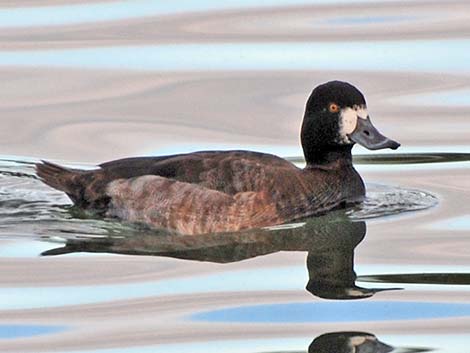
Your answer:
[99,151,298,194]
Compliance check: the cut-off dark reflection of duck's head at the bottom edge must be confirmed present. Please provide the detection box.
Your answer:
[308,332,395,353]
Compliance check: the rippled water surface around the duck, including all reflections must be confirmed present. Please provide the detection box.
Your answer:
[0,0,470,353]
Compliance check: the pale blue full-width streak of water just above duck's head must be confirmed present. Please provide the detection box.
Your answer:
[0,39,470,73]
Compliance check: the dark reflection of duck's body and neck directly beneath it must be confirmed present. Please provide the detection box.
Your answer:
[42,211,396,299]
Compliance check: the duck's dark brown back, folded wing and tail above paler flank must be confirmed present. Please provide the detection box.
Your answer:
[36,151,299,211]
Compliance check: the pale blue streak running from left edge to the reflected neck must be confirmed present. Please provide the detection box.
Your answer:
[0,266,308,310]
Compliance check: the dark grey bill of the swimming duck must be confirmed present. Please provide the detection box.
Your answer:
[348,117,400,150]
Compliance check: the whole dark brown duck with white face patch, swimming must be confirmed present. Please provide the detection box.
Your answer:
[36,81,400,235]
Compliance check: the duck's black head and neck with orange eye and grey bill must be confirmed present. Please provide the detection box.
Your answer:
[301,81,400,165]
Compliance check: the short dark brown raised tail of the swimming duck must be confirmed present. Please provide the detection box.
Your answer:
[36,161,83,202]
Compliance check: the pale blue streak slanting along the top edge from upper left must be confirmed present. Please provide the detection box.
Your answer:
[0,0,418,28]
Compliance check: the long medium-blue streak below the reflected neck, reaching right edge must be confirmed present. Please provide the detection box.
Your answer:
[191,302,470,323]
